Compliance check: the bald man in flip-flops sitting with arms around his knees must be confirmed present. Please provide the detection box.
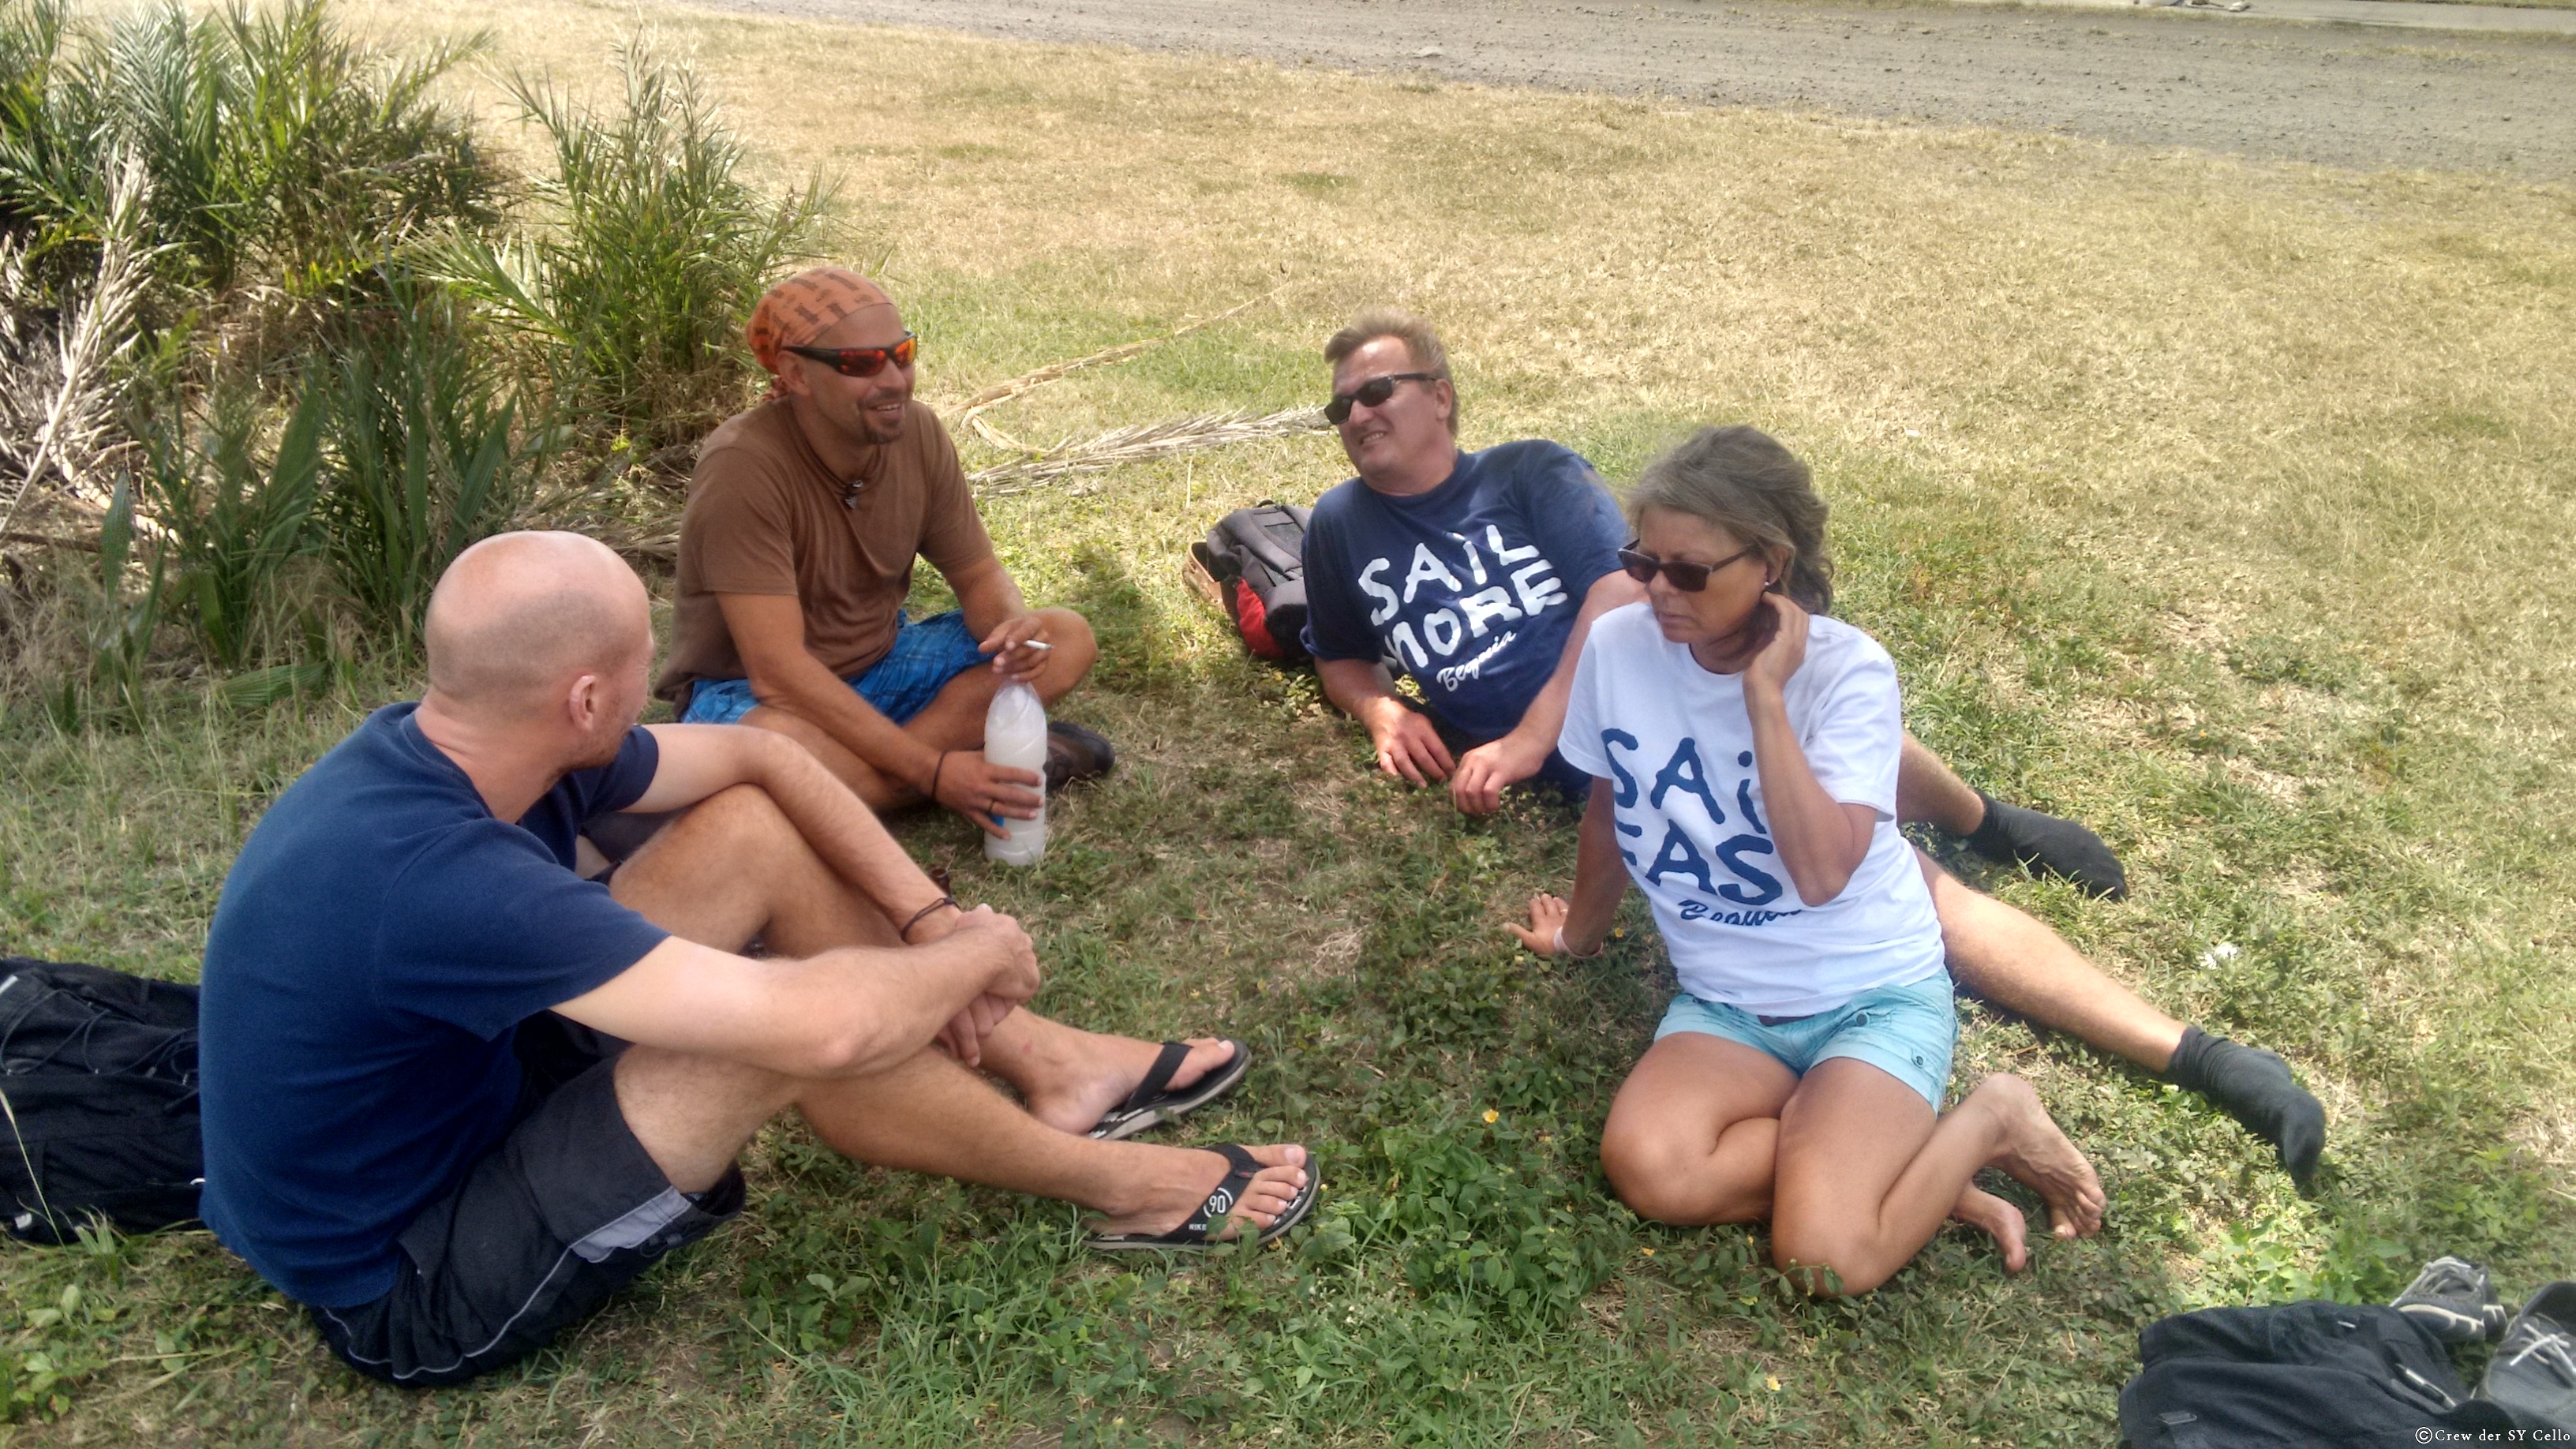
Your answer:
[201,534,1314,1387]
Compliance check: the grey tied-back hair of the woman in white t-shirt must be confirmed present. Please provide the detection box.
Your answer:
[1628,423,1834,614]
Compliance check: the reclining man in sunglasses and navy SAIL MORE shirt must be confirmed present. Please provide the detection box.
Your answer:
[1304,309,2326,1184]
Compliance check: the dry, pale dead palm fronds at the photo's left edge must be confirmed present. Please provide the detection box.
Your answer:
[0,152,149,546]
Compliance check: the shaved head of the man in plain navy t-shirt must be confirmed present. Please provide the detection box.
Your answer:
[425,534,652,719]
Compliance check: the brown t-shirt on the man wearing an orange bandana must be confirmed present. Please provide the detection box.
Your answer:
[657,397,992,706]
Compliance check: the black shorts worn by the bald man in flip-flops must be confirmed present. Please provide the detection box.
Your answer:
[312,1013,742,1387]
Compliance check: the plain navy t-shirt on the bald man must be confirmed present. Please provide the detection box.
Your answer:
[198,704,667,1307]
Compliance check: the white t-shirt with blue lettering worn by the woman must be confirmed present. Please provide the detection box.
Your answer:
[1559,603,1942,1016]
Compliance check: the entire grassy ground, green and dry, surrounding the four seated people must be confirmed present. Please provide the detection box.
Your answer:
[0,0,2576,1443]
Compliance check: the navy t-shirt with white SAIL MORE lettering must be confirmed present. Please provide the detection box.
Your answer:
[1306,438,1626,740]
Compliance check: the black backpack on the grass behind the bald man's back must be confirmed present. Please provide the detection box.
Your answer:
[0,957,206,1243]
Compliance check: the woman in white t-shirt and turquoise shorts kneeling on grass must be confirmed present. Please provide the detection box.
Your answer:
[1512,428,2102,1292]
